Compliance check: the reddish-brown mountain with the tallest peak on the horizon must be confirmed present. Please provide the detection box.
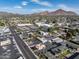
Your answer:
[38,9,77,15]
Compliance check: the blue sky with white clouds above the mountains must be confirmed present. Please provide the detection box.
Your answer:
[0,0,79,14]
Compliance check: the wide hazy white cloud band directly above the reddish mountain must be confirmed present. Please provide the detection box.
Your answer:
[31,4,79,14]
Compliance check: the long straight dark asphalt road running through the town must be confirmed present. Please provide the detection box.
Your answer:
[9,27,37,59]
